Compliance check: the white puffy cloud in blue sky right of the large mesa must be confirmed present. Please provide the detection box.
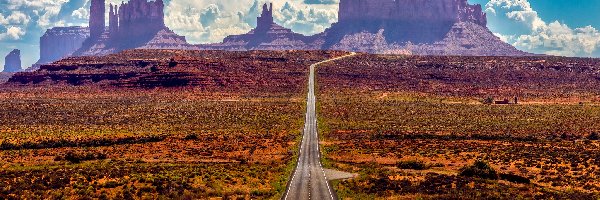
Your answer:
[486,0,600,56]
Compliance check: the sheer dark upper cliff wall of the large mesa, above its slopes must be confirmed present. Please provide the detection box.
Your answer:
[326,0,487,46]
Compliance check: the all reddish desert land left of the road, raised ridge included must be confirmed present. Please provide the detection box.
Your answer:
[0,50,344,199]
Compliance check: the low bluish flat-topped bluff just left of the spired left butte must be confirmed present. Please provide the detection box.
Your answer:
[36,26,90,64]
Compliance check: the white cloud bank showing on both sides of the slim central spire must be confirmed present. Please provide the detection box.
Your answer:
[166,0,337,43]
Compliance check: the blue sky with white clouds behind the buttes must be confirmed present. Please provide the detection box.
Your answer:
[0,0,600,71]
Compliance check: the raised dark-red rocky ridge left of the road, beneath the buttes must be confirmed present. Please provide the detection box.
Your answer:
[7,49,347,91]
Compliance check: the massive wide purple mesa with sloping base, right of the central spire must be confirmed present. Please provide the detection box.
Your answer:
[319,0,527,56]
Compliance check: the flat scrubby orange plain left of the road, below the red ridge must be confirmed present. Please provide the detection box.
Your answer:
[0,89,304,199]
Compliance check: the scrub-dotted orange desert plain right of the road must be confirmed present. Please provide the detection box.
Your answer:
[318,55,600,199]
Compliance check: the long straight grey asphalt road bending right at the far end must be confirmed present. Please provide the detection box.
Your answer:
[283,53,355,200]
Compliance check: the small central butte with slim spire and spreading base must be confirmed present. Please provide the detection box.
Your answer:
[197,4,320,50]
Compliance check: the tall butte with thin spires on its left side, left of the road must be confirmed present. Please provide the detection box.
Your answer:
[74,0,192,56]
